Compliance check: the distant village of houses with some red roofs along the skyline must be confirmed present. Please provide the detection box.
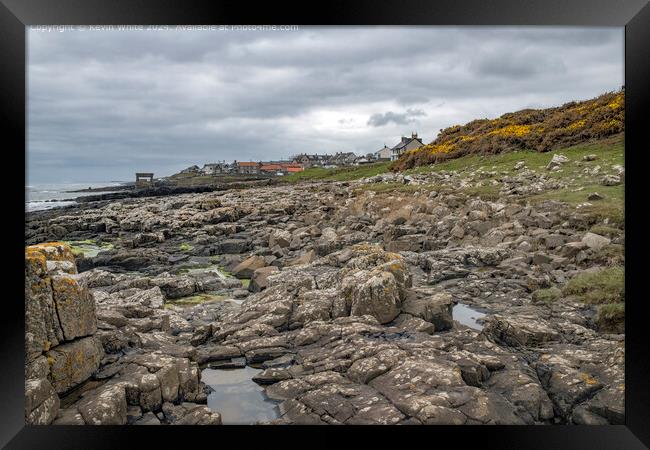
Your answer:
[173,133,424,176]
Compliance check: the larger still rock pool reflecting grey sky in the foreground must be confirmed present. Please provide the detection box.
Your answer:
[201,366,280,425]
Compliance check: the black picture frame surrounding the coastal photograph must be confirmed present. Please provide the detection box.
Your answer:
[0,0,650,450]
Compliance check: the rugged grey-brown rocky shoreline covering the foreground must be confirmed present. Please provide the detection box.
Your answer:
[25,159,625,424]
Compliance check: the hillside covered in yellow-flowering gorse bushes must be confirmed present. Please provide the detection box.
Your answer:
[390,91,625,171]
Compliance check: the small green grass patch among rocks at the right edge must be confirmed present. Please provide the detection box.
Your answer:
[563,266,625,304]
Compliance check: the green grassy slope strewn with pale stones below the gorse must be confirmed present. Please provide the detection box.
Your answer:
[284,135,625,225]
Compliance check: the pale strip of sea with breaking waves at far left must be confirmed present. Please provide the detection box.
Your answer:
[25,181,124,211]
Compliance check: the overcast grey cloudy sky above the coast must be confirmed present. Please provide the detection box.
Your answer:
[27,27,624,183]
